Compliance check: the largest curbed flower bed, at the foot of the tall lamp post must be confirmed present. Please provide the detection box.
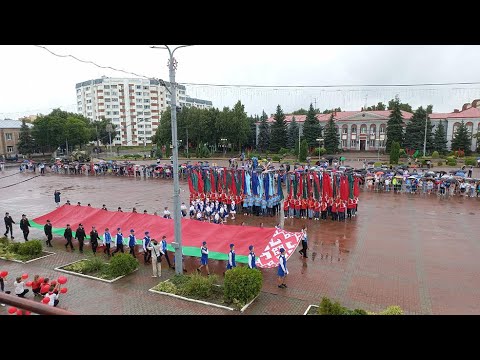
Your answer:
[149,267,262,312]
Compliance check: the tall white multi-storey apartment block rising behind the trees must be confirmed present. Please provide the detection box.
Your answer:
[75,77,186,146]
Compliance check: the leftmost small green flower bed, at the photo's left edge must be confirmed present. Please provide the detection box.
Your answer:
[0,237,55,263]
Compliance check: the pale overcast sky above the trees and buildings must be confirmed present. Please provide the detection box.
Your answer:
[0,45,480,119]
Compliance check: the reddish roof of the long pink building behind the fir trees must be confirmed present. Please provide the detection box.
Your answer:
[267,110,413,123]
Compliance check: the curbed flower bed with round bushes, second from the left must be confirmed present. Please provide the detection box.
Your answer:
[55,254,138,283]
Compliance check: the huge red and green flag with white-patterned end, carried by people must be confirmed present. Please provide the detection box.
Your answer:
[30,205,302,268]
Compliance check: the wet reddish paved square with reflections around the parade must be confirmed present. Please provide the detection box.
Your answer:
[0,169,480,314]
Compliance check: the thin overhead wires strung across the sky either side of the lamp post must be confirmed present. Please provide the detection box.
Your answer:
[34,45,480,89]
